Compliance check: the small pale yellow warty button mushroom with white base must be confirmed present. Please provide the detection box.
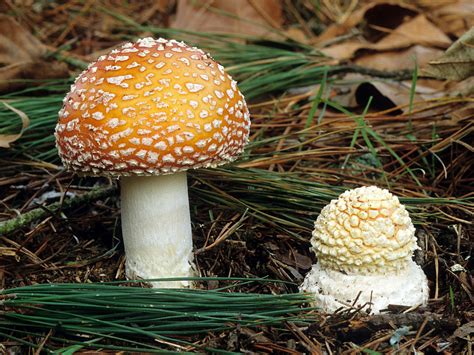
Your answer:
[300,186,428,313]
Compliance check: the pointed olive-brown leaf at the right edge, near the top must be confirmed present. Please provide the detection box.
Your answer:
[423,27,474,80]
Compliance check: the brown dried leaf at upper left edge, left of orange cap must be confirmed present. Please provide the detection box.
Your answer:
[0,14,69,92]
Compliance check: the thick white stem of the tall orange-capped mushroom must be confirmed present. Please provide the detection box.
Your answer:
[121,172,193,288]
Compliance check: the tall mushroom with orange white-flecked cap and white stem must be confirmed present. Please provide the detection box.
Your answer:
[55,38,250,287]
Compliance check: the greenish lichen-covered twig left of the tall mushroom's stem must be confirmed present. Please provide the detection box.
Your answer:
[0,186,116,235]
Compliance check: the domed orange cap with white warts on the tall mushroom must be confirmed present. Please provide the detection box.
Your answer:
[56,38,250,175]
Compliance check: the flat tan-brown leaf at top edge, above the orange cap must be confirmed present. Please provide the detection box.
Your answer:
[171,0,283,37]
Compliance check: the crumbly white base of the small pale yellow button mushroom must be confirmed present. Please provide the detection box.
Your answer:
[300,261,429,314]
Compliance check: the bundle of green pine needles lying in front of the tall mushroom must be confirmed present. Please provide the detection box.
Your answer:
[0,278,313,351]
